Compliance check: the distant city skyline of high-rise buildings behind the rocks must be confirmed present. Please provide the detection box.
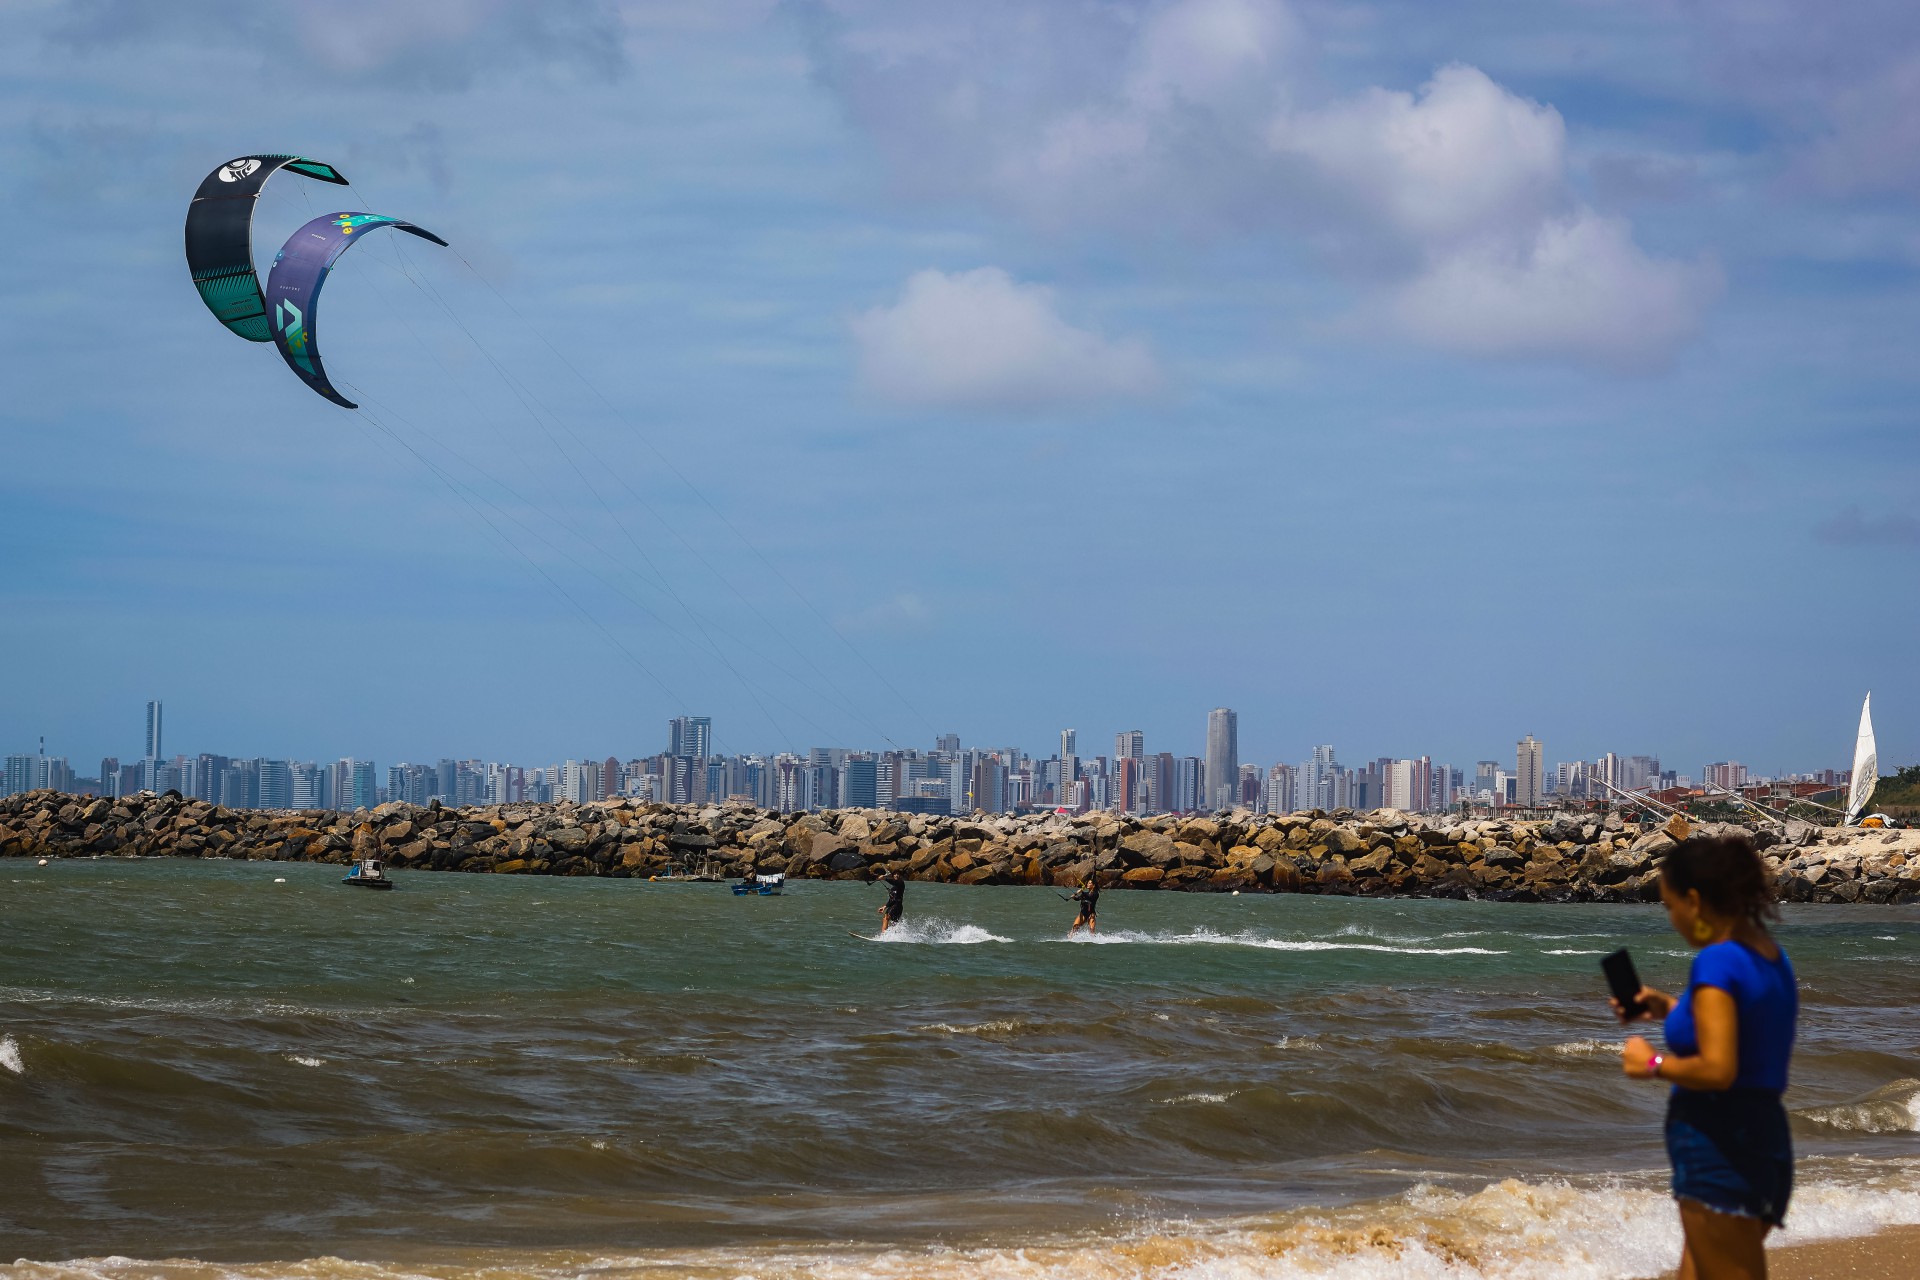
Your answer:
[0,699,1845,814]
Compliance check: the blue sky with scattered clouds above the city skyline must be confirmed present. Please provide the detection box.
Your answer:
[0,0,1920,775]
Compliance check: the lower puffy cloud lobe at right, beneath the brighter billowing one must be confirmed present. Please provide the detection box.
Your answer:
[1390,209,1720,372]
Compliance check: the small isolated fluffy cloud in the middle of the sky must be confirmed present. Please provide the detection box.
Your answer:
[852,267,1160,413]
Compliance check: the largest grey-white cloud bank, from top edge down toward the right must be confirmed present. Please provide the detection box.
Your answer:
[816,0,1720,370]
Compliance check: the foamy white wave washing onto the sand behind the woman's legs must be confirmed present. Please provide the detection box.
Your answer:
[22,1165,1920,1280]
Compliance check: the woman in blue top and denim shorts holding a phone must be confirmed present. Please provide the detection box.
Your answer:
[1613,837,1799,1280]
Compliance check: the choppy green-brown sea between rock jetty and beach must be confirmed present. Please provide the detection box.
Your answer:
[0,860,1920,1280]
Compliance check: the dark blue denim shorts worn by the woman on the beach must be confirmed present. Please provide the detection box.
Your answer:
[1667,1088,1793,1226]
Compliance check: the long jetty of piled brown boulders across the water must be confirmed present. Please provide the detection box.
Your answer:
[0,791,1920,902]
